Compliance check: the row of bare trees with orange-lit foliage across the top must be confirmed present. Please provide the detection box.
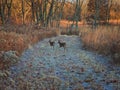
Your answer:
[0,0,120,27]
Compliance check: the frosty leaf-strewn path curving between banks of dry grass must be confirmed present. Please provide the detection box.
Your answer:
[11,36,120,90]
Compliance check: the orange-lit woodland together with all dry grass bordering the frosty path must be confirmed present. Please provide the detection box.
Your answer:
[0,0,120,68]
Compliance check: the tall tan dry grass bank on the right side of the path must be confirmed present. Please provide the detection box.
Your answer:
[80,26,120,62]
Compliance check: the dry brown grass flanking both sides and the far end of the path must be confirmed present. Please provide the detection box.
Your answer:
[0,21,120,70]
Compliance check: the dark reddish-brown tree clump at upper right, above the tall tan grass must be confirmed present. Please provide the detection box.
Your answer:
[87,0,112,27]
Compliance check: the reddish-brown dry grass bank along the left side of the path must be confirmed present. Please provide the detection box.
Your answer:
[0,25,57,69]
